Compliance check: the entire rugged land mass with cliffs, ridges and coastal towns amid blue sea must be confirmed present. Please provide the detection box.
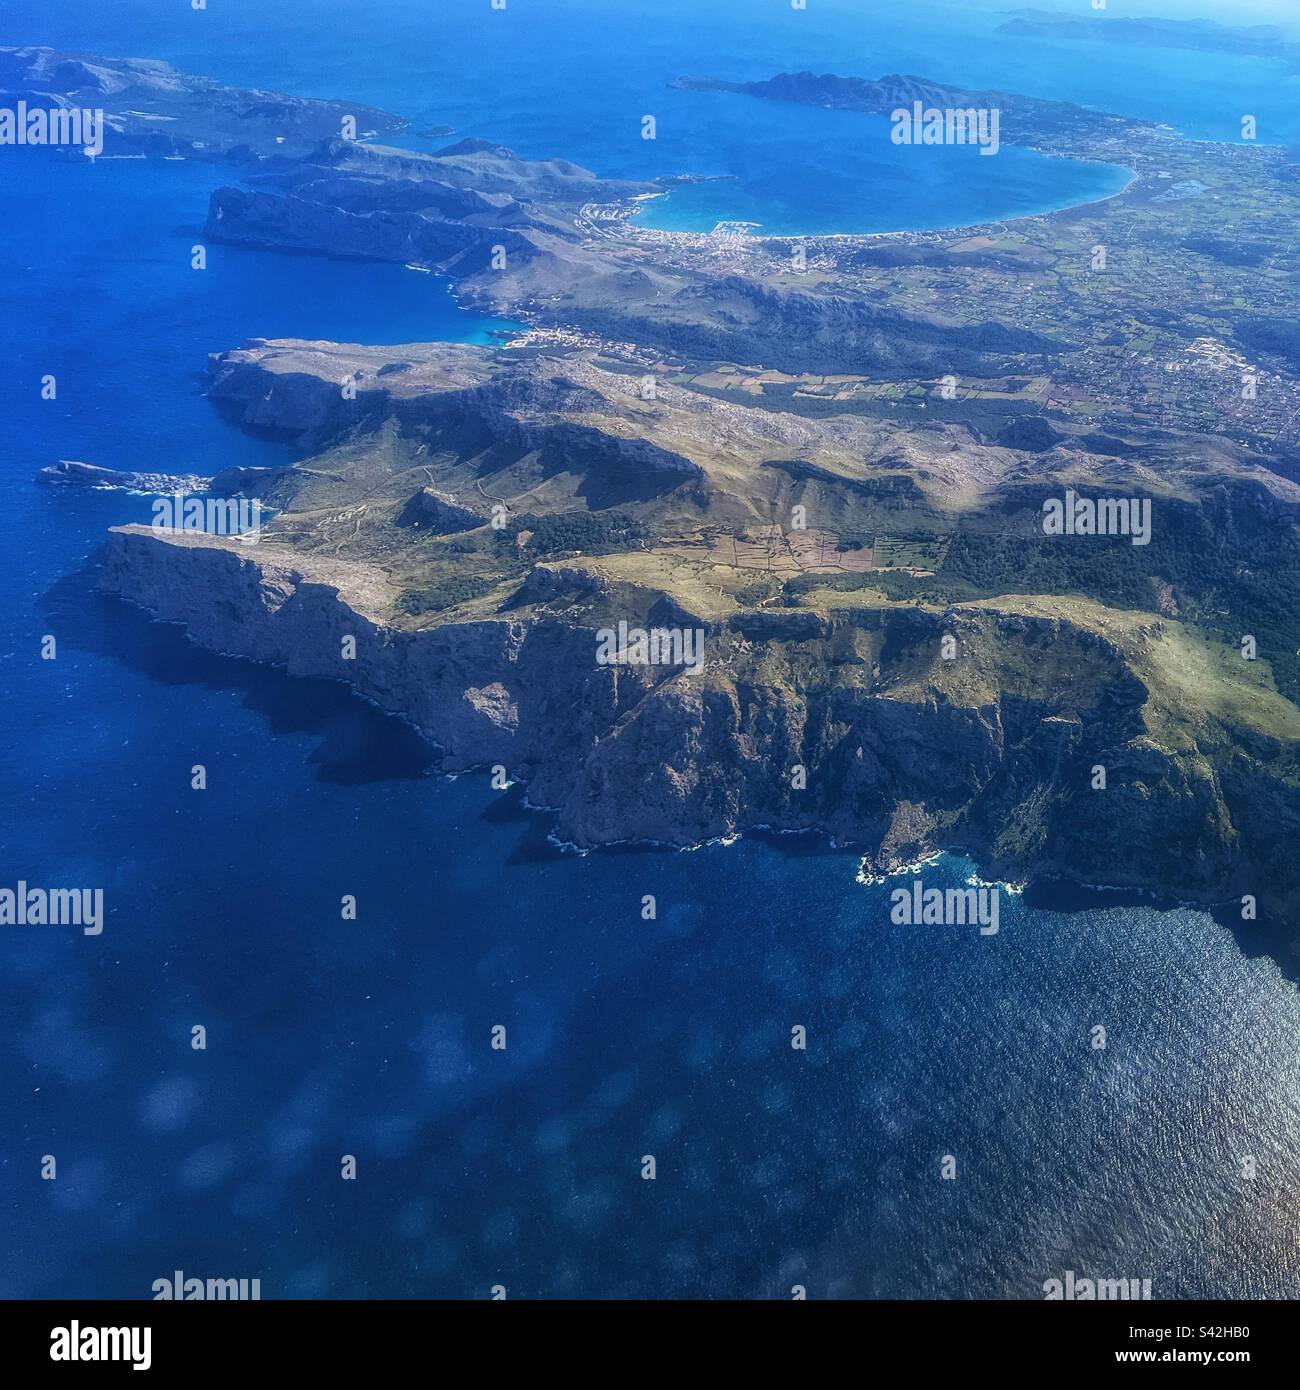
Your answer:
[12,49,1300,934]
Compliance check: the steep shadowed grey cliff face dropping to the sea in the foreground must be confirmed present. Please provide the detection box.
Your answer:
[101,527,1296,910]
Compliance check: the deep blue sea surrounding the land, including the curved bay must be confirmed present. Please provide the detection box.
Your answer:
[0,0,1300,1298]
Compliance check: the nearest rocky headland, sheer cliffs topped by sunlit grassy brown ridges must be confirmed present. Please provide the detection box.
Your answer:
[103,342,1300,906]
